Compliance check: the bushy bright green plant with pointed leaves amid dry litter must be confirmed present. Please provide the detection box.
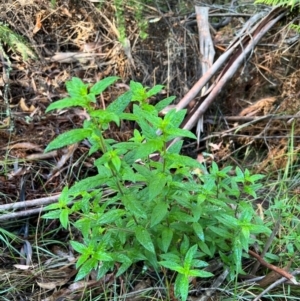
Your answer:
[43,77,270,300]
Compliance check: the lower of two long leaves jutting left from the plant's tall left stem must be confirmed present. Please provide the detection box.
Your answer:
[45,129,91,152]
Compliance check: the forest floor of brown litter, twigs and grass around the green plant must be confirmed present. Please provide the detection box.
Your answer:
[0,0,300,301]
